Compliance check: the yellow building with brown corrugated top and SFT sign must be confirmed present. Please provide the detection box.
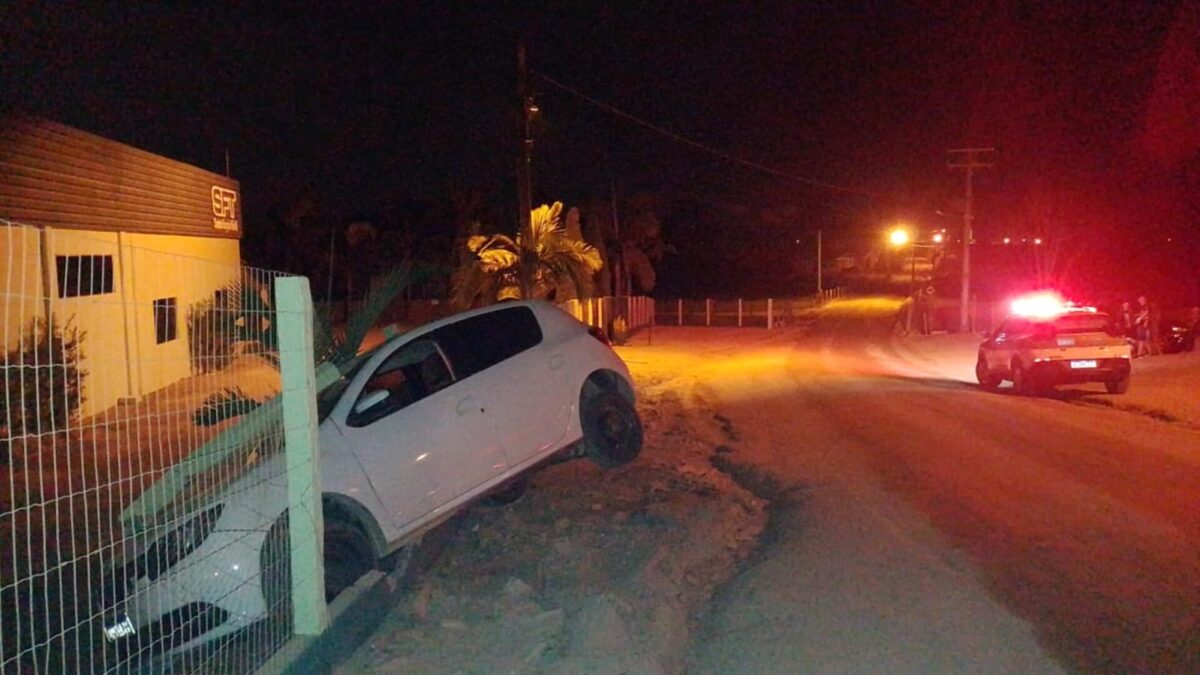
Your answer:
[0,117,242,416]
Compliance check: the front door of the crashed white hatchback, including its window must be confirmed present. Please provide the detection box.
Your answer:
[341,336,508,527]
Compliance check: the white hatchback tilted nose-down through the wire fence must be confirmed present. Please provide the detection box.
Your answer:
[104,301,642,653]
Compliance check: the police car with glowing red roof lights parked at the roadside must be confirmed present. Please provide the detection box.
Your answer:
[976,293,1132,395]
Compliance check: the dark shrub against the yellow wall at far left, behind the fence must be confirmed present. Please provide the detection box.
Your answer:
[0,316,88,464]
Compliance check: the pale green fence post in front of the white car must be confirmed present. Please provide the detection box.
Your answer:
[275,276,329,635]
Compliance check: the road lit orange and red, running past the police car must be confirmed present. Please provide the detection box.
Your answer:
[635,301,1200,673]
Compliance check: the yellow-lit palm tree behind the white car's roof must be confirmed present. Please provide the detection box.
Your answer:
[451,202,604,307]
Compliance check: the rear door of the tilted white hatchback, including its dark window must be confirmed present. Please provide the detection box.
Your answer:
[434,305,578,466]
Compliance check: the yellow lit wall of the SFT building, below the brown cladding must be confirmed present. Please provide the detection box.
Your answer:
[0,226,241,417]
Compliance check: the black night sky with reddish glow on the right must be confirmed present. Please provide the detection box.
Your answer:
[0,0,1200,299]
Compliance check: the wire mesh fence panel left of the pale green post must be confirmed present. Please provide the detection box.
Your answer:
[0,220,319,673]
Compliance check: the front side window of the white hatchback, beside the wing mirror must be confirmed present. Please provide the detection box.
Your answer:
[346,338,455,426]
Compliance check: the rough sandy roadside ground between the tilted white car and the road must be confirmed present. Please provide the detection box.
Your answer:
[336,341,767,674]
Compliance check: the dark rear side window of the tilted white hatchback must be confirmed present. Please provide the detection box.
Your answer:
[431,306,542,380]
